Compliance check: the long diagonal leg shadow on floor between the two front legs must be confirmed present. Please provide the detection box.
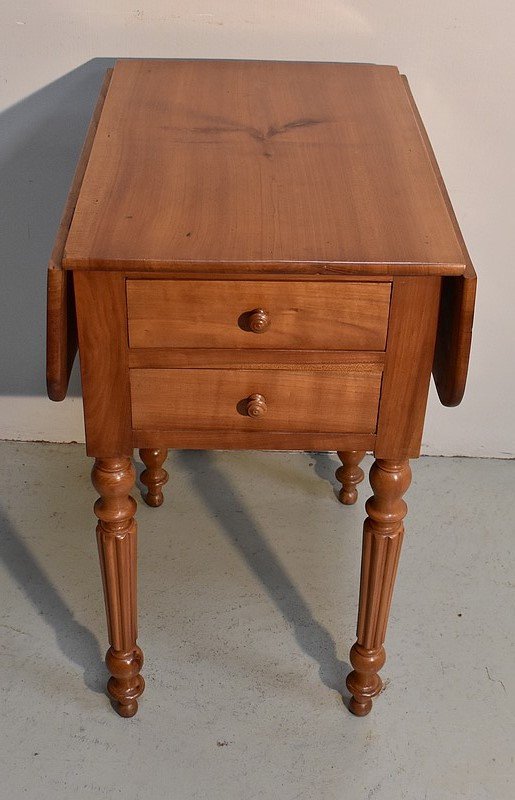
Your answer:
[178,450,351,699]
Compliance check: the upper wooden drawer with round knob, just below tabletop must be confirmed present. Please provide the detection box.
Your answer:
[127,280,391,350]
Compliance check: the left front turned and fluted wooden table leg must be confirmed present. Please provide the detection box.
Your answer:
[92,458,145,717]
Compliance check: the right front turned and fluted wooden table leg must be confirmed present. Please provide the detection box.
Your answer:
[347,460,411,717]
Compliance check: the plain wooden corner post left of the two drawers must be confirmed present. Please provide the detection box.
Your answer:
[74,272,133,458]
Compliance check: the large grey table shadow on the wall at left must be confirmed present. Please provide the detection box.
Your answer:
[0,58,115,395]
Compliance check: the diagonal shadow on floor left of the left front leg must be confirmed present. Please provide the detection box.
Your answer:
[0,511,107,694]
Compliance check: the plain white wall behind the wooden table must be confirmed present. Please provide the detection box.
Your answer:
[0,0,515,457]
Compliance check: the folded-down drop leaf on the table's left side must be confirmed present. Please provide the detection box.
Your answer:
[46,69,113,401]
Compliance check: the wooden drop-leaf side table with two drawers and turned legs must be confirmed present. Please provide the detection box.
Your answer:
[47,60,476,717]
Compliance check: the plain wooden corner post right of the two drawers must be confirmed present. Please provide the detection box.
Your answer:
[375,277,440,458]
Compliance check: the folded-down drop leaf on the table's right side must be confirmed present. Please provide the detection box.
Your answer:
[402,75,477,406]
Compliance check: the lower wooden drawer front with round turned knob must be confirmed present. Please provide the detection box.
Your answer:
[130,365,382,433]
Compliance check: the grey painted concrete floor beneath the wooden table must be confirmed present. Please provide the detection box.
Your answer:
[0,442,515,800]
